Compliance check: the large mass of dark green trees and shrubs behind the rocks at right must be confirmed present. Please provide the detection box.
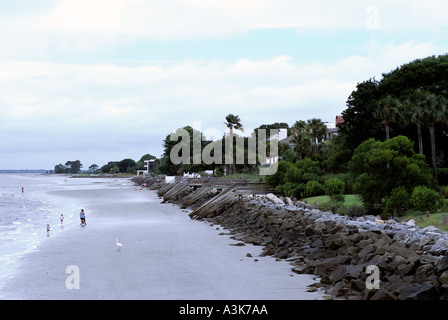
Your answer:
[267,55,448,214]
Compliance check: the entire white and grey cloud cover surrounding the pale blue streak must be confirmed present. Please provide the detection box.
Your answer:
[0,0,445,167]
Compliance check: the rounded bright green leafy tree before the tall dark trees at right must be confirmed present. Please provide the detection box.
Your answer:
[350,136,431,212]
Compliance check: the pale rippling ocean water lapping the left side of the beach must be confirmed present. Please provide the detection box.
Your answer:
[0,174,81,288]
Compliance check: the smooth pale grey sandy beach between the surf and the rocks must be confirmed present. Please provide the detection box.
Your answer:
[0,182,322,300]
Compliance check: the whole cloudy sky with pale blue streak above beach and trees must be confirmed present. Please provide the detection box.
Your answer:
[0,0,448,170]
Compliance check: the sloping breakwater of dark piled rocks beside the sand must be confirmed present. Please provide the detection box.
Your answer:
[147,178,448,300]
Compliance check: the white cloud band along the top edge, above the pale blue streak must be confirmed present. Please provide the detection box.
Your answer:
[3,0,448,47]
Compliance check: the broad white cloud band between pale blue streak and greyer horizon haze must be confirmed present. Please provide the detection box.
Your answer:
[0,42,437,132]
